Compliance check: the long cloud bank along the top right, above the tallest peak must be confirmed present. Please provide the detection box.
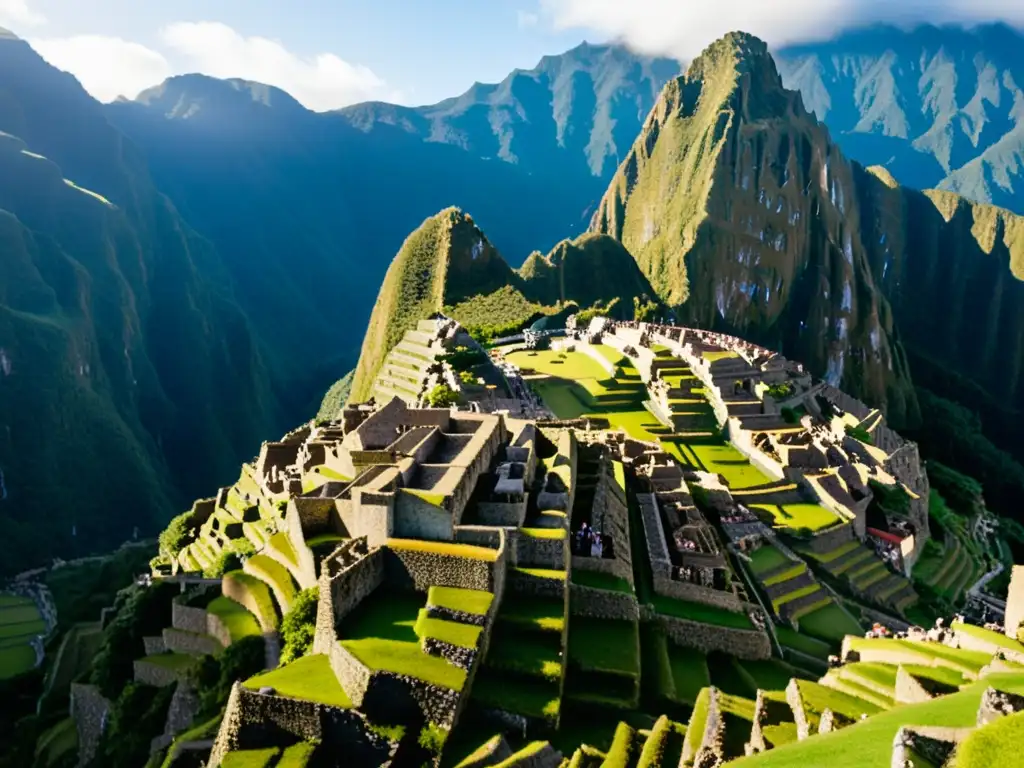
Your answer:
[541,0,1024,58]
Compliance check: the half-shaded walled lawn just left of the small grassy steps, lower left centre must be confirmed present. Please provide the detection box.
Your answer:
[338,591,466,690]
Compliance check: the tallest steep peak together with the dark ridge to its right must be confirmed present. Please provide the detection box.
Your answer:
[591,34,1024,434]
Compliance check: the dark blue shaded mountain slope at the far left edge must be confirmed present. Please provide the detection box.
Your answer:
[0,34,282,572]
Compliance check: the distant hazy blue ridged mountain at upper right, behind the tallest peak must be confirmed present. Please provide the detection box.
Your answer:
[775,25,1024,213]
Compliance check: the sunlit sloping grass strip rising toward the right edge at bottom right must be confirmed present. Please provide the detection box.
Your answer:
[730,674,1024,768]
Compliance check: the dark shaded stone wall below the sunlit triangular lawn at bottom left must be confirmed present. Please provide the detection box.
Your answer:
[209,682,397,768]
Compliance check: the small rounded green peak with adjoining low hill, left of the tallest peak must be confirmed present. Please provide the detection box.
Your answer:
[350,208,653,403]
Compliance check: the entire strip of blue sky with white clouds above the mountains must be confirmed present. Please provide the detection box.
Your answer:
[0,0,1024,110]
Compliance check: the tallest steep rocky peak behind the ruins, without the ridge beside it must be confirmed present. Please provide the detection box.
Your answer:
[591,34,916,424]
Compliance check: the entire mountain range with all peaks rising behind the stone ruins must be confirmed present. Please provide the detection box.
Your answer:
[0,22,1024,568]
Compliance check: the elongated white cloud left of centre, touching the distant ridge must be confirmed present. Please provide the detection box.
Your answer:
[161,22,391,111]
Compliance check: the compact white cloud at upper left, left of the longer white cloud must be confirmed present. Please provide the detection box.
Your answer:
[29,35,171,101]
